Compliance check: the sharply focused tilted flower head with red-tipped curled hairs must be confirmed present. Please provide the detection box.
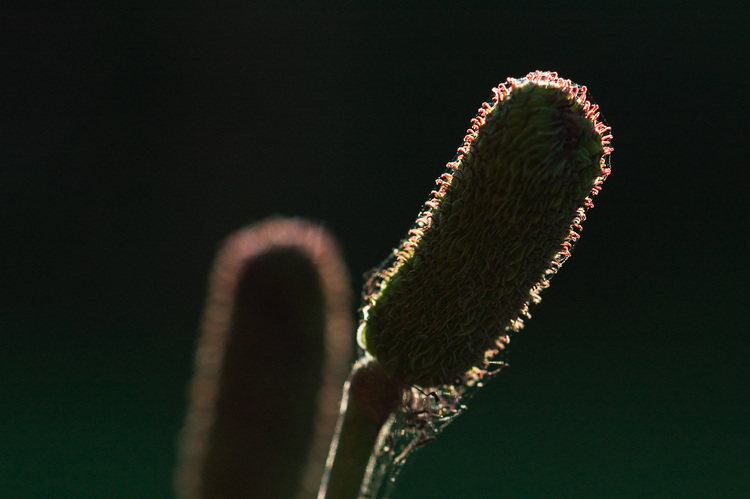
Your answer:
[358,71,612,387]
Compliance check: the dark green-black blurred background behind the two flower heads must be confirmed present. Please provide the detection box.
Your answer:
[0,5,750,498]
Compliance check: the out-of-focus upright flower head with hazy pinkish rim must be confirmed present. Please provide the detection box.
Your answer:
[175,217,353,499]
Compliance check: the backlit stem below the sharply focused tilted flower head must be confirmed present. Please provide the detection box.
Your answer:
[318,357,402,499]
